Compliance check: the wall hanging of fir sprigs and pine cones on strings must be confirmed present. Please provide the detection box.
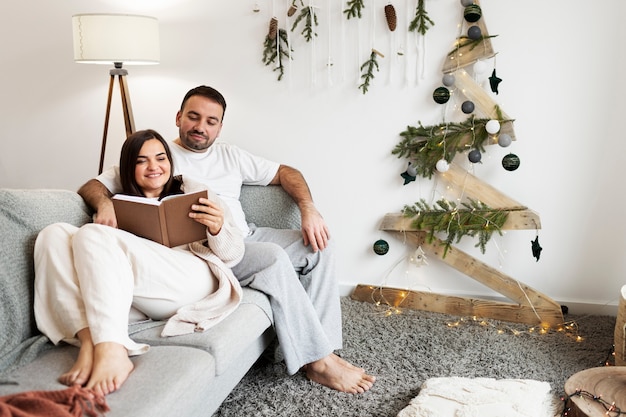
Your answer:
[254,0,434,94]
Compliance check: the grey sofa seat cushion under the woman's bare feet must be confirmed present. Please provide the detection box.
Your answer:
[0,345,215,417]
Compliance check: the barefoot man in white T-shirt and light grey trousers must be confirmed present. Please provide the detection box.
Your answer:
[78,86,375,393]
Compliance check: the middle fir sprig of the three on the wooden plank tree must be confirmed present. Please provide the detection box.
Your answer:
[391,107,511,178]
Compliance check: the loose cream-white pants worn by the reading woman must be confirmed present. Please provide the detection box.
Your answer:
[34,223,217,355]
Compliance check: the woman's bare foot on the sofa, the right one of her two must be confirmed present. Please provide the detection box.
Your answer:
[85,342,134,395]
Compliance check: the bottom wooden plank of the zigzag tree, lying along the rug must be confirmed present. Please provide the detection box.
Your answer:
[351,284,563,325]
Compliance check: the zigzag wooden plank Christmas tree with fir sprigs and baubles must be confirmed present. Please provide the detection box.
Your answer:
[352,0,563,326]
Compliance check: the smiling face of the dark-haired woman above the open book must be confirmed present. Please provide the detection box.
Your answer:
[135,139,172,197]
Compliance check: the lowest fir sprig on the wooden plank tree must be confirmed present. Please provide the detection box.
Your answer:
[402,199,509,258]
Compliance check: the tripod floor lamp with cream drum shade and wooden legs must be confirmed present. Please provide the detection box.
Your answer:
[72,14,160,174]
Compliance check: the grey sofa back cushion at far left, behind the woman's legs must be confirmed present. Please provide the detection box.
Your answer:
[0,189,91,372]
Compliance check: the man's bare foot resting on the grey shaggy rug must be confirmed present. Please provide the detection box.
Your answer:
[304,353,376,394]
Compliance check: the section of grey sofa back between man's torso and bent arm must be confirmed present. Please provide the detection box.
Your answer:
[239,185,301,229]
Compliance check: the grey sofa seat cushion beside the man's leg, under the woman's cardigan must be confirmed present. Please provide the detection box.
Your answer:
[129,287,273,375]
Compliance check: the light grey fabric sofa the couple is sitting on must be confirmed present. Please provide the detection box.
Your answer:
[0,186,300,417]
